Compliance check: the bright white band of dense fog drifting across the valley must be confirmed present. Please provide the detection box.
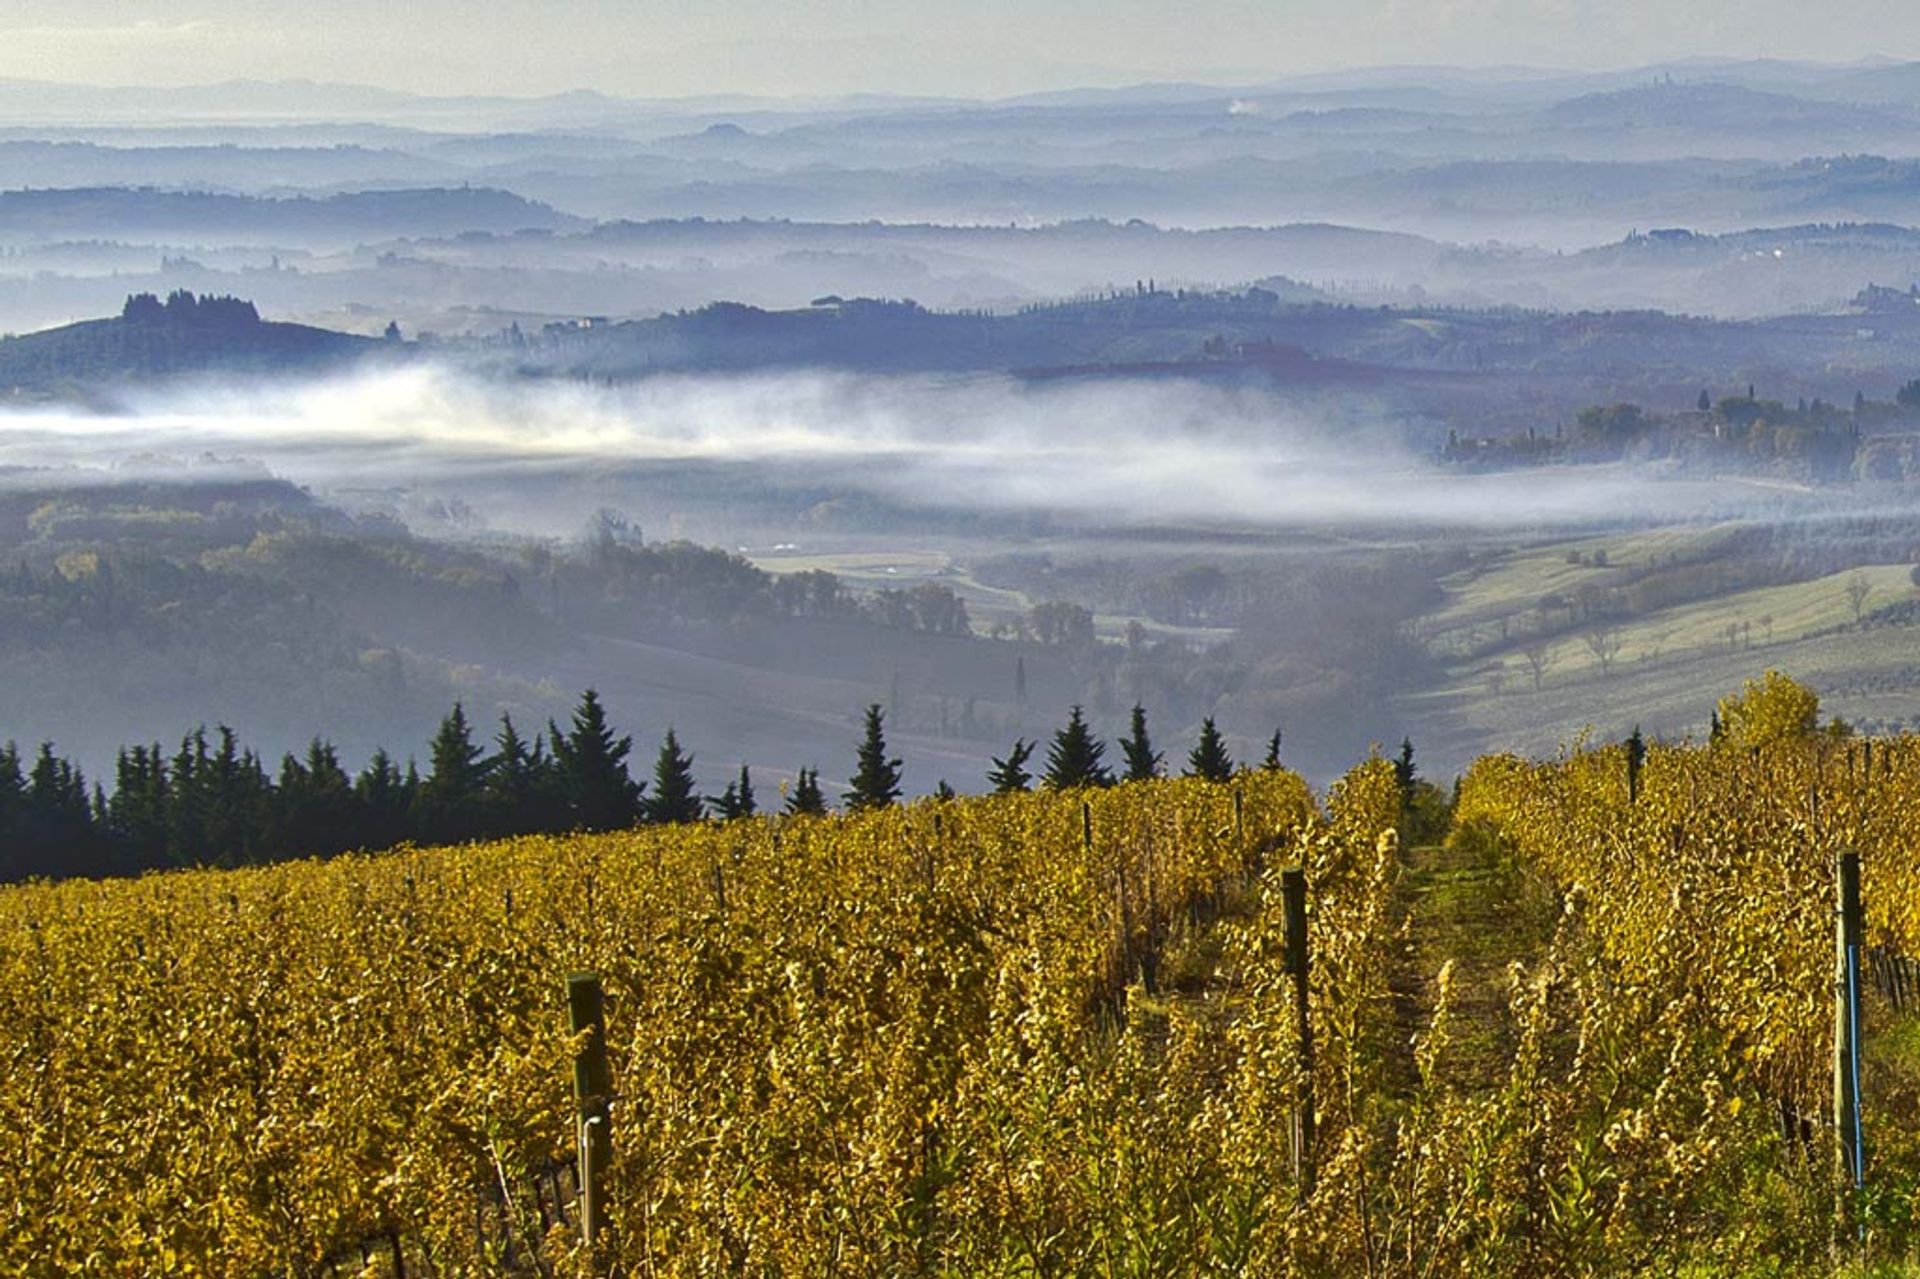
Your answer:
[0,367,1791,534]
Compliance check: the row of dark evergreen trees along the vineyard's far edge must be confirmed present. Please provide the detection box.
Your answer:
[0,689,1290,881]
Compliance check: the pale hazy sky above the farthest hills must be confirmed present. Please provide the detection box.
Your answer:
[0,0,1920,96]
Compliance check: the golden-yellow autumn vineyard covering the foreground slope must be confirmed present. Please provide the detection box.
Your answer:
[0,691,1920,1277]
